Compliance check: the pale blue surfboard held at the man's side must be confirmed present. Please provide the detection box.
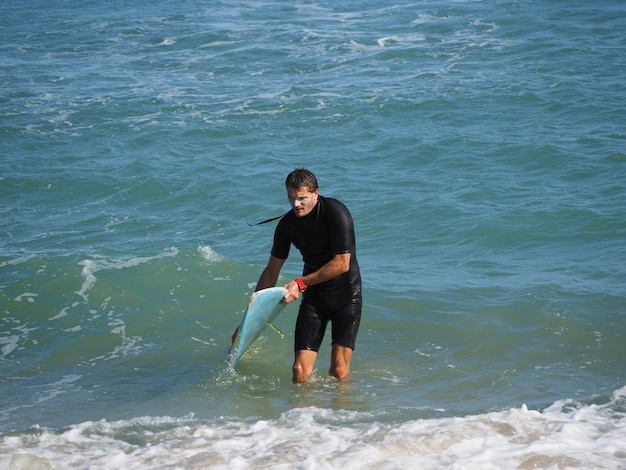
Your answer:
[229,287,287,367]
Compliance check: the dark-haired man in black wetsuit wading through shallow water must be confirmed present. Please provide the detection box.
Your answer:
[256,168,361,383]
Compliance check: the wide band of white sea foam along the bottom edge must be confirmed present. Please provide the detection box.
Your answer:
[0,387,626,469]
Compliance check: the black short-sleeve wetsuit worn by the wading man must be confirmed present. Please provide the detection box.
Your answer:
[272,196,362,352]
